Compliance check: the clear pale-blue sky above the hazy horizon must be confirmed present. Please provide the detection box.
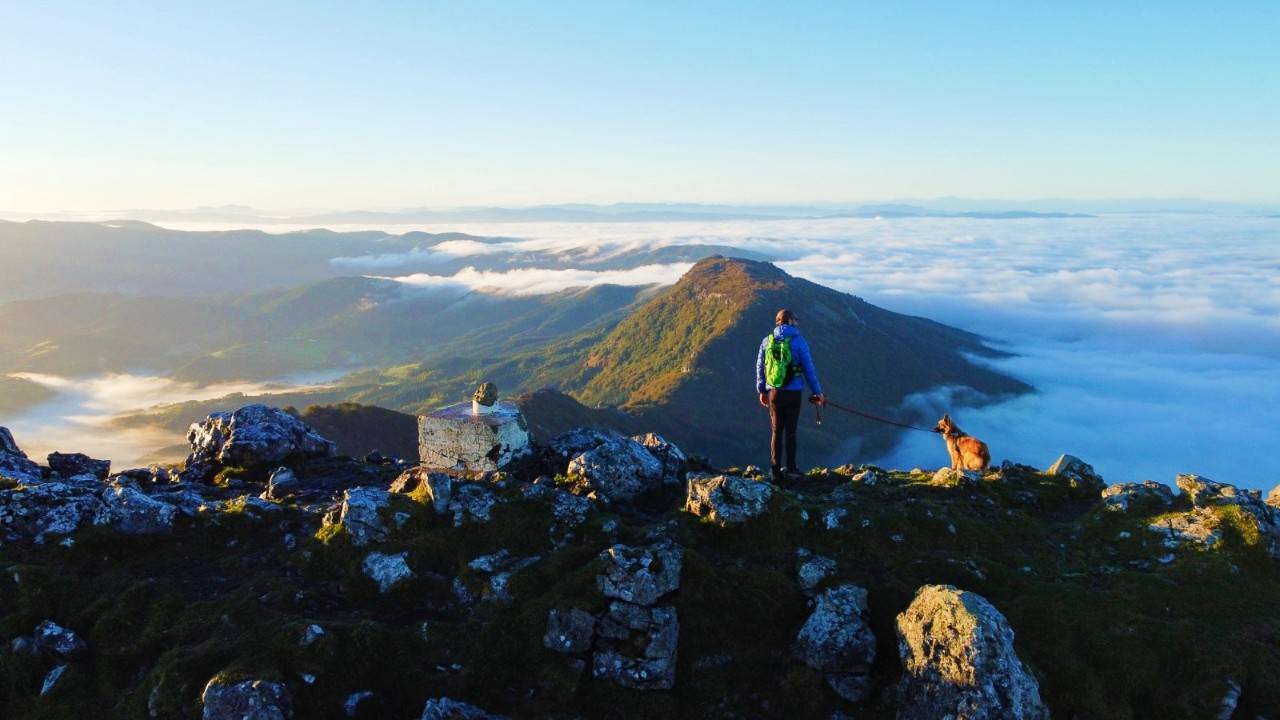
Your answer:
[0,1,1280,211]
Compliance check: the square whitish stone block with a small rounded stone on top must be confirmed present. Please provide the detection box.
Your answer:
[417,402,531,473]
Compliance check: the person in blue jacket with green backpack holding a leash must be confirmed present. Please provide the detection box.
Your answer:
[755,309,827,482]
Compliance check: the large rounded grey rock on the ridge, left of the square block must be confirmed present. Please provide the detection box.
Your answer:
[183,405,337,480]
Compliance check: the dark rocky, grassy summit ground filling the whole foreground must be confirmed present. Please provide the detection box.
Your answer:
[0,407,1280,720]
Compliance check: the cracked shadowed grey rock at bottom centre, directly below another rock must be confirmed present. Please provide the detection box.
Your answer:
[591,602,680,691]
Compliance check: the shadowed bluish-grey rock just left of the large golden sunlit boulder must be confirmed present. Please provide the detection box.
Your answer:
[794,584,876,702]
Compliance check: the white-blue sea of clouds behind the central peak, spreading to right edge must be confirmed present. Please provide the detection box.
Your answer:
[330,214,1280,488]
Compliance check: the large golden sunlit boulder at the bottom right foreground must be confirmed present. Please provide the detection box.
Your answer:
[897,585,1048,720]
